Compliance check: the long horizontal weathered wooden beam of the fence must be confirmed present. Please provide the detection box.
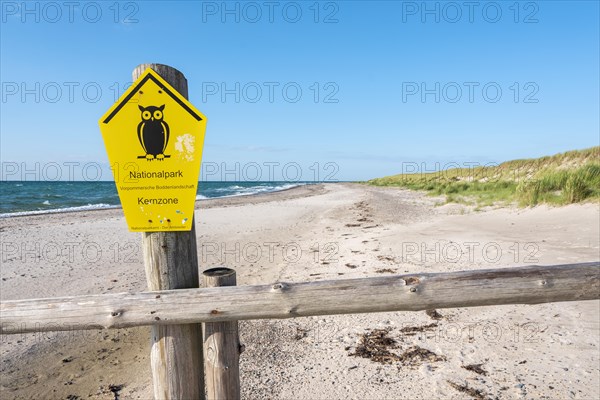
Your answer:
[0,262,600,334]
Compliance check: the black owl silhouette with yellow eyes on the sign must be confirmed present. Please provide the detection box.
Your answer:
[138,104,170,161]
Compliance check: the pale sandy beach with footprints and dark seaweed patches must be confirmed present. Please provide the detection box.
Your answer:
[0,183,600,400]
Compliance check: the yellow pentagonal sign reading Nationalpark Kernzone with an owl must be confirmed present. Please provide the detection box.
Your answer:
[99,68,206,232]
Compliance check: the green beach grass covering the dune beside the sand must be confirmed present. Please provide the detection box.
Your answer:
[367,146,600,207]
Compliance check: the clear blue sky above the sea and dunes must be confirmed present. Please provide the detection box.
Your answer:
[0,1,600,180]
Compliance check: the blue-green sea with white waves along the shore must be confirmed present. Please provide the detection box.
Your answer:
[0,181,310,218]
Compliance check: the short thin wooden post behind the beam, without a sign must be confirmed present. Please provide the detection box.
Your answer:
[202,268,242,400]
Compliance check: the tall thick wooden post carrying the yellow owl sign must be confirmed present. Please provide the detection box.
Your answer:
[132,64,204,400]
